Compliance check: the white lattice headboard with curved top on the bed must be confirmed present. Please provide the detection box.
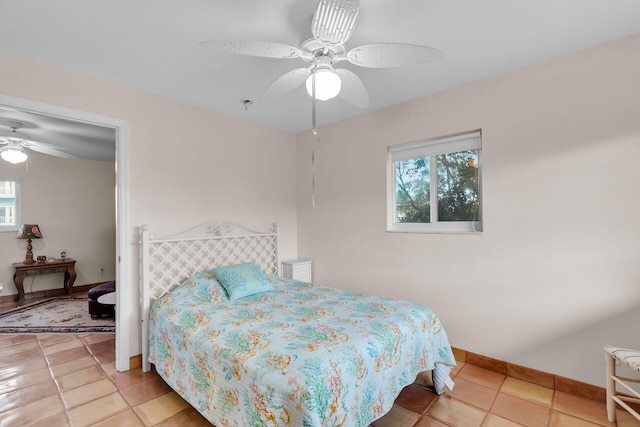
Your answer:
[140,221,281,372]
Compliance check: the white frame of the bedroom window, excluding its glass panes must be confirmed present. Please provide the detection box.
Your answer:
[387,130,483,234]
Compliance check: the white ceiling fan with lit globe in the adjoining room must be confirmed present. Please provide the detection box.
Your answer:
[0,121,77,164]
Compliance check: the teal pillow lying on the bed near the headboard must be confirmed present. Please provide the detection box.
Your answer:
[211,262,273,301]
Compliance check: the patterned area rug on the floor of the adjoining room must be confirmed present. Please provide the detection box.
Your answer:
[0,298,116,334]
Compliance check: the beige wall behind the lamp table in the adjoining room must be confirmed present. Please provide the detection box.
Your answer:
[0,152,116,295]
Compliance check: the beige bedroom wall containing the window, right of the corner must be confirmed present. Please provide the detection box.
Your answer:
[298,35,640,386]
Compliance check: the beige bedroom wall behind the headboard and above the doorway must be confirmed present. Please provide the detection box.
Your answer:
[0,52,297,355]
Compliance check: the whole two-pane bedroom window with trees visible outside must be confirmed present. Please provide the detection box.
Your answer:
[387,130,482,233]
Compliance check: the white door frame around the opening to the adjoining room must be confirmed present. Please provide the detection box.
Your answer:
[0,93,132,371]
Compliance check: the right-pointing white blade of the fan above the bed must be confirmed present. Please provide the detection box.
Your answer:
[347,43,444,68]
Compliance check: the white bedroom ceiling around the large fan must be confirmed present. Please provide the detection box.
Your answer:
[0,0,640,160]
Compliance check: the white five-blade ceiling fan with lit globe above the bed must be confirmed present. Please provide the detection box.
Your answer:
[200,0,444,108]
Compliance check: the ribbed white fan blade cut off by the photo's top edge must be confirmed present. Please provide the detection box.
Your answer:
[311,0,360,47]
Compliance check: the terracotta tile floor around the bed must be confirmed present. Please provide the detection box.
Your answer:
[0,334,640,427]
